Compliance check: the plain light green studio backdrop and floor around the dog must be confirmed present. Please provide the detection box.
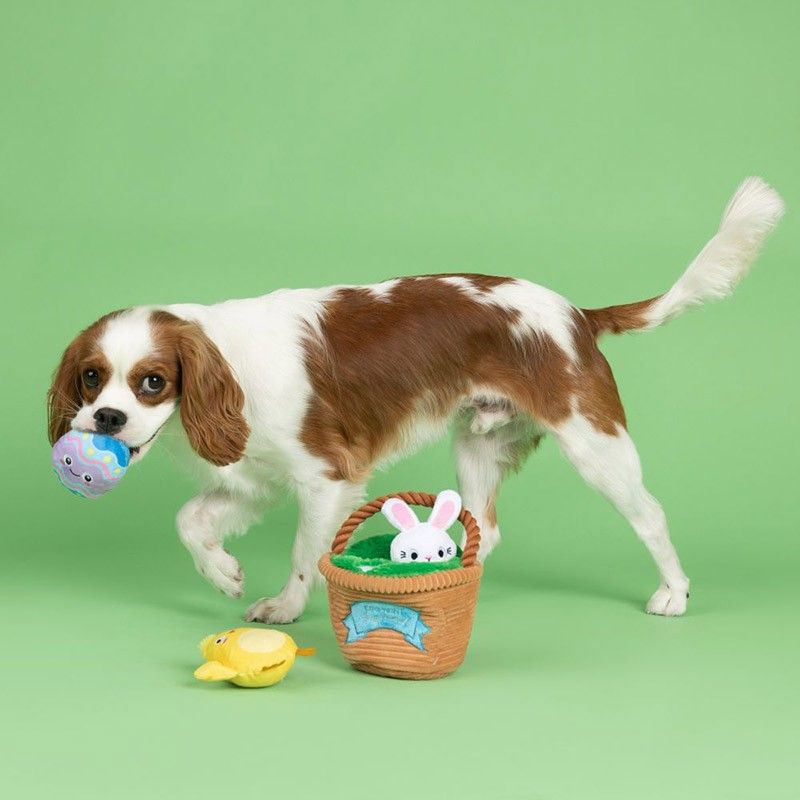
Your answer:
[0,0,800,800]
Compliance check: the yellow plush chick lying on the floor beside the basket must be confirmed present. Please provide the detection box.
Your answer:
[194,628,315,688]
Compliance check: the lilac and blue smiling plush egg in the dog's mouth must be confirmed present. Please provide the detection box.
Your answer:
[53,431,131,499]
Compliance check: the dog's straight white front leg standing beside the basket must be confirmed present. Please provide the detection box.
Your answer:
[244,476,364,624]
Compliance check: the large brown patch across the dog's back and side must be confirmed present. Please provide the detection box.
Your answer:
[300,276,588,481]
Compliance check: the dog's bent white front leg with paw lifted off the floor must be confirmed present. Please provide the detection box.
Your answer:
[177,490,262,598]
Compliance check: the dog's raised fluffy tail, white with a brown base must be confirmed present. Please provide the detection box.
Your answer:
[583,178,784,336]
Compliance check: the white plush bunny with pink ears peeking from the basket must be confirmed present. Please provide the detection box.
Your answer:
[381,489,461,564]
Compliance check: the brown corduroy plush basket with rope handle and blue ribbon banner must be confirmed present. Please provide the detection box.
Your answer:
[319,492,483,680]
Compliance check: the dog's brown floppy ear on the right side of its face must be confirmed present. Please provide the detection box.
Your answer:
[159,312,250,467]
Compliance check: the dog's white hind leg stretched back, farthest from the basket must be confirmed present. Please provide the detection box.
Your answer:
[553,414,689,617]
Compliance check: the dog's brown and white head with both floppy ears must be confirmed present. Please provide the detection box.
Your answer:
[47,308,250,466]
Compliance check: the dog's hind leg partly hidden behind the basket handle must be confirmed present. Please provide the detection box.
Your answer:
[453,412,541,561]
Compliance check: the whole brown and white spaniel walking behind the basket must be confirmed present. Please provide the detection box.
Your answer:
[49,178,783,623]
